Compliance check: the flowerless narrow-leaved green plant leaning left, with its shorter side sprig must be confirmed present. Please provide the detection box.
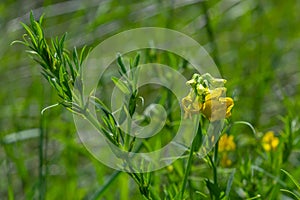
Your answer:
[15,13,156,199]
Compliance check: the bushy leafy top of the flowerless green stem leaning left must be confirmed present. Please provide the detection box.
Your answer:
[14,12,87,108]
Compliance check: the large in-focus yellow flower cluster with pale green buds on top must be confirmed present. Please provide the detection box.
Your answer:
[182,73,234,122]
